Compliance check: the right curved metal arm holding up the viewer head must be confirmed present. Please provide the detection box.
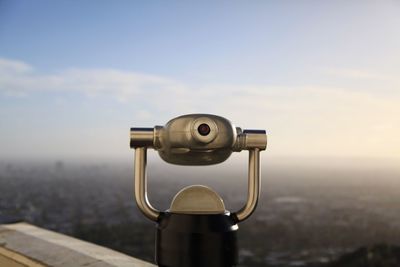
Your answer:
[236,148,261,222]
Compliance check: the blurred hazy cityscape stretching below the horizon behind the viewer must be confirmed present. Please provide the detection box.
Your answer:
[0,161,400,267]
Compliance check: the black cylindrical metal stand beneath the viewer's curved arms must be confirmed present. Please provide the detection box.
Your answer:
[156,212,239,267]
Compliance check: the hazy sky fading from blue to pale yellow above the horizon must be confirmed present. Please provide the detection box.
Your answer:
[0,0,400,161]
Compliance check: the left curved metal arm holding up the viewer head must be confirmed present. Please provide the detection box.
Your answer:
[134,147,160,221]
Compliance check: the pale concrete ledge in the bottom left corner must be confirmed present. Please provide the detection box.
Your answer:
[0,223,156,267]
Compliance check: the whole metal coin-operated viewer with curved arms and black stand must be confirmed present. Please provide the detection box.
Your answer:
[130,114,267,267]
